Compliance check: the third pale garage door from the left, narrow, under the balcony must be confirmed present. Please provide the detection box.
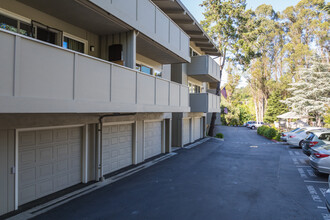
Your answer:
[144,121,162,159]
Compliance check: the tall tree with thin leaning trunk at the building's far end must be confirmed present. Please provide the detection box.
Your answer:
[201,0,254,136]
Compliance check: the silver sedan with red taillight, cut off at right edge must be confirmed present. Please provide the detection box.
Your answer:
[309,144,330,174]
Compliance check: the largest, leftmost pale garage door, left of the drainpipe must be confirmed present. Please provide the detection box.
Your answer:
[18,127,82,205]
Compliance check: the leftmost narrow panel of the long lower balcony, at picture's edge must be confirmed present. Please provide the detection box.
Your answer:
[0,35,15,96]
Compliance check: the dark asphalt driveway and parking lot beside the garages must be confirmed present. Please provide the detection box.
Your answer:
[21,127,330,220]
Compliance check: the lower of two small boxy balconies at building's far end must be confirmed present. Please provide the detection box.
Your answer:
[189,93,220,113]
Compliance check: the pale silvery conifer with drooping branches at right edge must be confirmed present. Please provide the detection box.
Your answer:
[283,58,330,126]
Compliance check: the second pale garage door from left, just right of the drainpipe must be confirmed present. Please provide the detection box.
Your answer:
[102,124,133,174]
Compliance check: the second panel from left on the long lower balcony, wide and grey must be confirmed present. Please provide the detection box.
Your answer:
[19,38,74,100]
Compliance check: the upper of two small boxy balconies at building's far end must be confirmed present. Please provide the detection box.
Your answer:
[187,55,220,82]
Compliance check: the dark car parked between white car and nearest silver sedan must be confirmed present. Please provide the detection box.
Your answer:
[302,129,330,156]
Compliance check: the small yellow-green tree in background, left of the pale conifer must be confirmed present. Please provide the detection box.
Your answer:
[264,91,288,123]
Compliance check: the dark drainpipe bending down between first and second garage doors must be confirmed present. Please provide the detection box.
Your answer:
[97,113,136,181]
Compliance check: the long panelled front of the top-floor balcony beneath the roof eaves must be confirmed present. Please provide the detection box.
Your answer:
[90,0,190,62]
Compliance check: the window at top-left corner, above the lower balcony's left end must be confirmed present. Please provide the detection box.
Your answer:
[0,11,32,37]
